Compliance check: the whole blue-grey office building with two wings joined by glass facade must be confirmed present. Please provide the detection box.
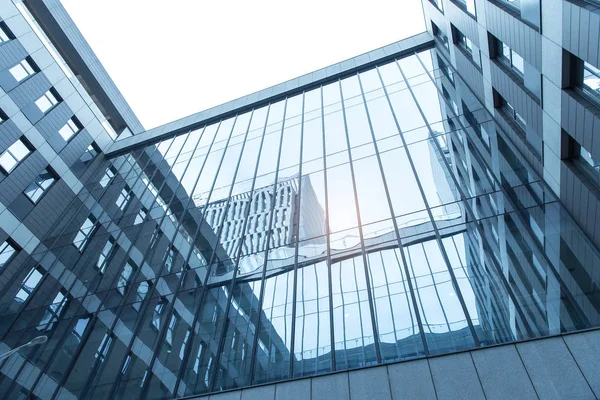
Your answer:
[0,0,600,400]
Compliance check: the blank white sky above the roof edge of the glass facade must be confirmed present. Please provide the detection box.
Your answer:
[61,0,424,129]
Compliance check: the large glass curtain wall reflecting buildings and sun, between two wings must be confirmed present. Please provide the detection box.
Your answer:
[0,50,600,399]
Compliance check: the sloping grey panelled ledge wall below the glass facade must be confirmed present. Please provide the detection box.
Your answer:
[190,330,600,400]
